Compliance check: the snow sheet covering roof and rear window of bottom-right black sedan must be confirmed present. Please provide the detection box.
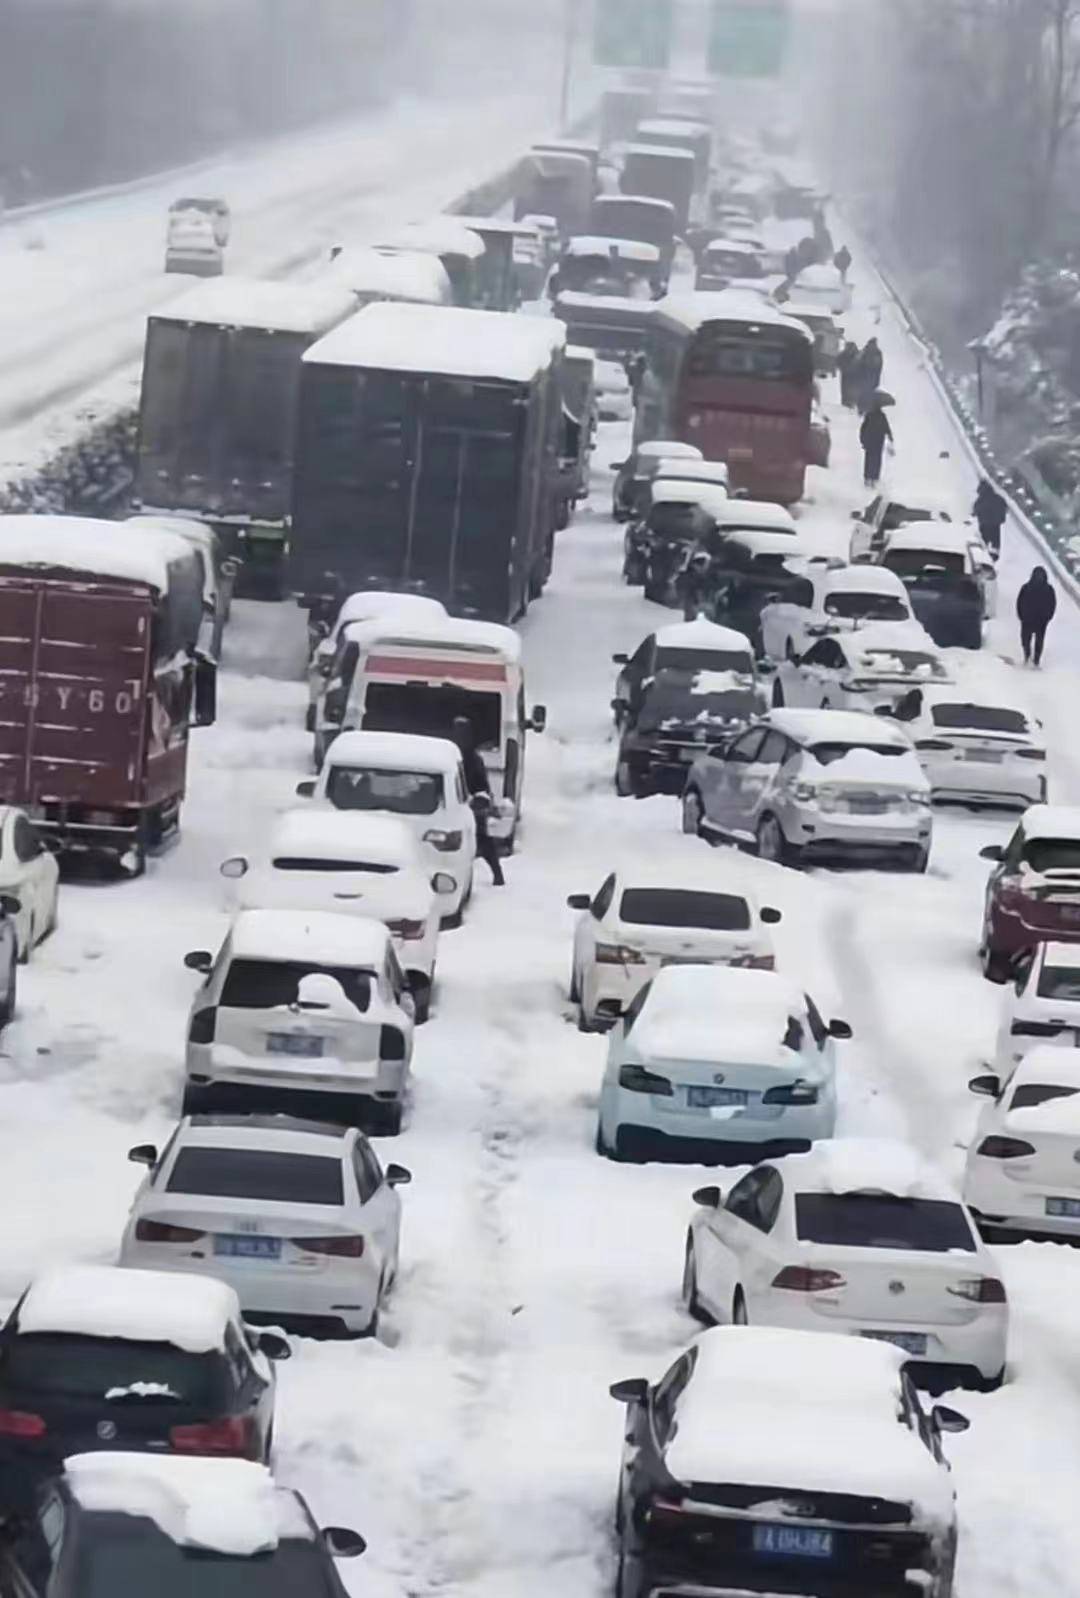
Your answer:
[666,1326,954,1521]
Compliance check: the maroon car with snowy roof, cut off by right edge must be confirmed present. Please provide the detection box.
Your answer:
[979,804,1080,983]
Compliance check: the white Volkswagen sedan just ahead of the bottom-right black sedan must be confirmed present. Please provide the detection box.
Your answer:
[682,1138,1008,1389]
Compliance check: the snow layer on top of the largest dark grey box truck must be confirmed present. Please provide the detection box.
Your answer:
[304,302,566,384]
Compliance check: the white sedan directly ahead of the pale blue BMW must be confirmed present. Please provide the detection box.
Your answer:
[567,855,780,1032]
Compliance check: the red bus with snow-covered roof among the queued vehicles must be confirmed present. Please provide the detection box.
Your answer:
[634,291,813,505]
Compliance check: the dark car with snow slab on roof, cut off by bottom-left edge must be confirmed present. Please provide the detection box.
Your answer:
[0,1453,366,1598]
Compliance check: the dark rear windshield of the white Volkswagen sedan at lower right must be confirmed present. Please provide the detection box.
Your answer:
[796,1194,975,1254]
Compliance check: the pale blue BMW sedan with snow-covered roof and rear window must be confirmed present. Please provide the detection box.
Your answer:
[596,965,852,1163]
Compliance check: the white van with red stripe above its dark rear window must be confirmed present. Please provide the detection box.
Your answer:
[329,617,548,849]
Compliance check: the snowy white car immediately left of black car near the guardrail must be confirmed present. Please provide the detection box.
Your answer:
[760,559,914,660]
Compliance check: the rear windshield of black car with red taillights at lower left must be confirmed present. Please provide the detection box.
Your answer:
[0,1333,224,1405]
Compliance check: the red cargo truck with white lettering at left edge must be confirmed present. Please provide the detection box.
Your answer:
[0,516,216,876]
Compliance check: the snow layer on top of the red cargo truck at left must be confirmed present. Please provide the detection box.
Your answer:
[0,516,185,593]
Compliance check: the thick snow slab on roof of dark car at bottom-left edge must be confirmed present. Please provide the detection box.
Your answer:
[64,1457,315,1558]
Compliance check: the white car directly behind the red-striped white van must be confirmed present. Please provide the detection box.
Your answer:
[297,732,476,927]
